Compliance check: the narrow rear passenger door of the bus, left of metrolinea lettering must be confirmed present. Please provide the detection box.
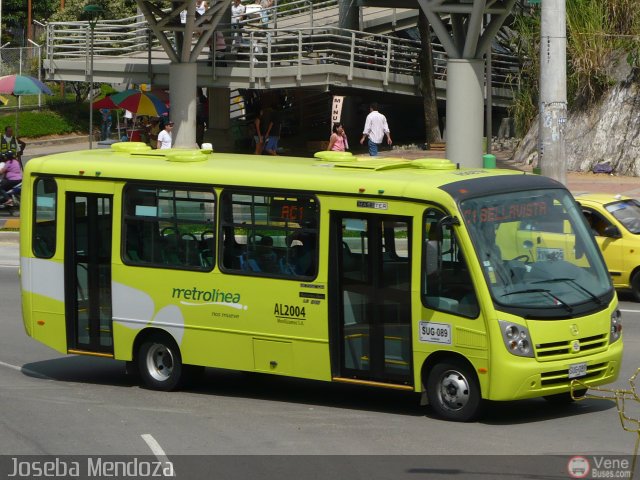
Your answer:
[64,193,113,354]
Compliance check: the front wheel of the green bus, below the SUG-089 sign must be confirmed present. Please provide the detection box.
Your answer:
[427,358,482,422]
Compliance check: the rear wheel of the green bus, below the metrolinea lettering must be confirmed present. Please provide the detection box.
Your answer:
[137,336,183,392]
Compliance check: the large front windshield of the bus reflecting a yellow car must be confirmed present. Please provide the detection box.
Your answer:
[460,188,612,318]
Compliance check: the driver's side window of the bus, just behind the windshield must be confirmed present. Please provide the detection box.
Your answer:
[422,209,480,317]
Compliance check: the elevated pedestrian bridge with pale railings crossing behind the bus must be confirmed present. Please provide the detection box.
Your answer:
[44,4,518,106]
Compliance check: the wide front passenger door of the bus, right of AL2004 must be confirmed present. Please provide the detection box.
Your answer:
[329,213,413,386]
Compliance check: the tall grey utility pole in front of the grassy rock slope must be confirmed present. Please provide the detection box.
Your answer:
[538,0,567,185]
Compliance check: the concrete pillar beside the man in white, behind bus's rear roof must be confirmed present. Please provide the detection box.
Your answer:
[169,63,198,148]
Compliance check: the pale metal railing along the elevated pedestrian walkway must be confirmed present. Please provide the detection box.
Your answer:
[46,9,519,94]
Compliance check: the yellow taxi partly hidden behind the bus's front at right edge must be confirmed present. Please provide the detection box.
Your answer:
[575,193,640,302]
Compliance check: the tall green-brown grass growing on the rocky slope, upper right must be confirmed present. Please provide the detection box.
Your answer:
[511,0,640,136]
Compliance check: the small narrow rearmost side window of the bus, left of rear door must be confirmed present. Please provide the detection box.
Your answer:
[31,178,58,258]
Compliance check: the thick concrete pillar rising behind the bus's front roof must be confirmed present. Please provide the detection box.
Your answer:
[446,59,484,168]
